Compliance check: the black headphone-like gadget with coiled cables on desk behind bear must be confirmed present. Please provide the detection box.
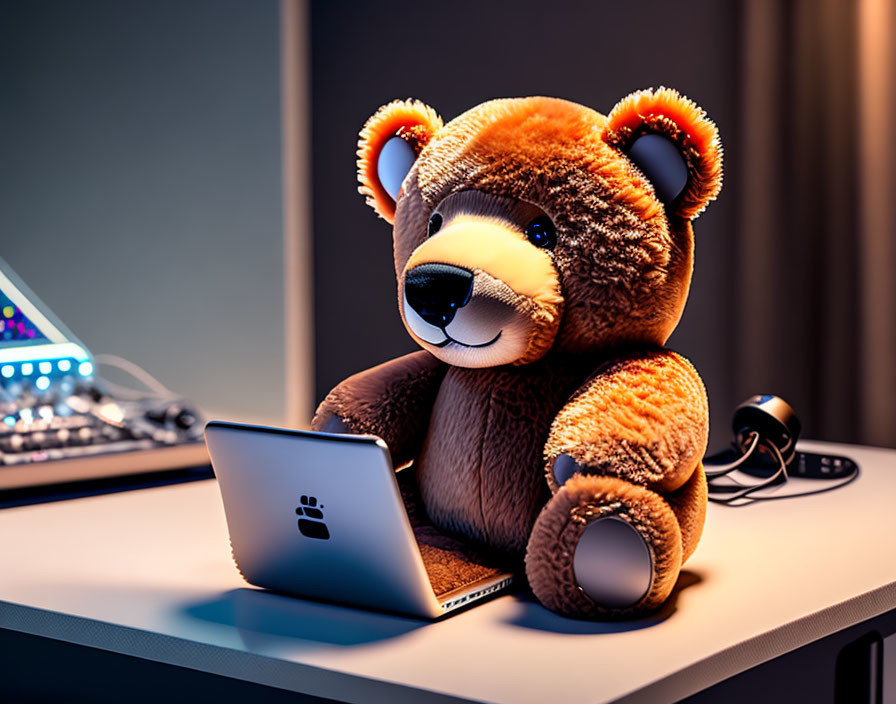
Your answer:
[703,394,859,505]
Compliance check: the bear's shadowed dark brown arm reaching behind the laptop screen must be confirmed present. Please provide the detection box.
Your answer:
[311,351,447,468]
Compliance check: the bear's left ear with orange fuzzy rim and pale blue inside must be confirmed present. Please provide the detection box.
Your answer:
[358,99,442,223]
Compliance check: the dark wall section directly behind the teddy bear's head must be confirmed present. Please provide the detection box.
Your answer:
[311,0,738,446]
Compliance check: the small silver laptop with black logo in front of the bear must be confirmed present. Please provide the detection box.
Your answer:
[205,421,513,618]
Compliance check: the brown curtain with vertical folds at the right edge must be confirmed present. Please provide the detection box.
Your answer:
[732,0,896,446]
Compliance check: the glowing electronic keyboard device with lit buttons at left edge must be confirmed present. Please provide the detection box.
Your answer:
[0,259,208,490]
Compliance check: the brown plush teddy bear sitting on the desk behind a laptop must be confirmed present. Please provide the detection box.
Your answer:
[312,89,722,618]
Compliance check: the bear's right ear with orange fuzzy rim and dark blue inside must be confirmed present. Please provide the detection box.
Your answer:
[603,88,722,219]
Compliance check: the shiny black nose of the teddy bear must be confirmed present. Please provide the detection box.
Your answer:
[404,264,473,328]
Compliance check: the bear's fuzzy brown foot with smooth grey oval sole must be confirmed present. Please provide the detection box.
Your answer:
[526,474,682,619]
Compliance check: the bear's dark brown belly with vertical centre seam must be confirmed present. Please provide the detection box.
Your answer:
[416,356,590,556]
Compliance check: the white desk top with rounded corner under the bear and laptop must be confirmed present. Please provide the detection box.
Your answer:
[0,443,896,702]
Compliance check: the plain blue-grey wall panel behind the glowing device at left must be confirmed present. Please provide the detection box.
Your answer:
[0,0,284,420]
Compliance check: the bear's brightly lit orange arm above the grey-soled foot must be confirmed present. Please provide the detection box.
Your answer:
[545,349,709,494]
